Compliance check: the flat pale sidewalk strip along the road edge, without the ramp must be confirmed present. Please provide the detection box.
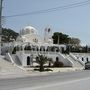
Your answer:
[0,68,83,79]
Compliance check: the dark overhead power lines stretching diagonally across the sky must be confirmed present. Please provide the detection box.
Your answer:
[5,0,90,18]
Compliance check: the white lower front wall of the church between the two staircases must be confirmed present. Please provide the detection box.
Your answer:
[16,51,72,66]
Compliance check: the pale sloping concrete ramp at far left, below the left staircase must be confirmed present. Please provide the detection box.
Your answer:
[0,57,24,74]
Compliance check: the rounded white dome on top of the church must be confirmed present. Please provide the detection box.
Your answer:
[20,26,37,35]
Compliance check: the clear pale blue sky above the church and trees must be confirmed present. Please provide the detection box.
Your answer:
[3,0,90,45]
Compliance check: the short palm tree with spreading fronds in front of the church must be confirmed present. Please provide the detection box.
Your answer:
[36,54,48,72]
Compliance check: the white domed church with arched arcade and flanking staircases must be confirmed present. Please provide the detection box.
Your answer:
[2,26,83,67]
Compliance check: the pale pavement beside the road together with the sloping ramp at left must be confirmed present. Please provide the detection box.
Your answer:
[0,57,83,79]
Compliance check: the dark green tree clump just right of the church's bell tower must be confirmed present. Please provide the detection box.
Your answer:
[52,32,80,46]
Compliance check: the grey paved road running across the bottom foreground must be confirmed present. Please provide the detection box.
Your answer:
[0,70,90,90]
